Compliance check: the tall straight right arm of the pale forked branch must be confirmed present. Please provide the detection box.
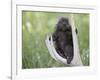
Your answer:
[69,14,83,66]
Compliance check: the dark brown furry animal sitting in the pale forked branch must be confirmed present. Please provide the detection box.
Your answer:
[53,17,74,64]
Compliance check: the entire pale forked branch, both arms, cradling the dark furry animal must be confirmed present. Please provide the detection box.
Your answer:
[46,14,83,66]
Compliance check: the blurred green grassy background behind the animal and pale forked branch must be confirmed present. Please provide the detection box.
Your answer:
[22,11,89,69]
